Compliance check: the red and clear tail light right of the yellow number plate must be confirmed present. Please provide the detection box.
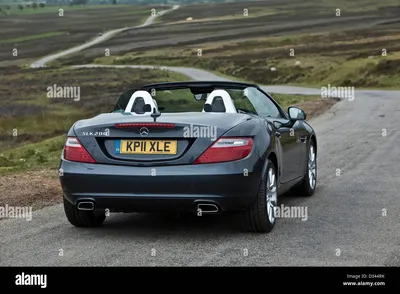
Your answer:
[194,138,253,164]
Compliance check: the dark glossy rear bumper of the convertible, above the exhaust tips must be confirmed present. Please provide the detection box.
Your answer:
[60,157,263,212]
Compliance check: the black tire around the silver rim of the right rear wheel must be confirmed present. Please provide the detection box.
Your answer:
[244,160,278,233]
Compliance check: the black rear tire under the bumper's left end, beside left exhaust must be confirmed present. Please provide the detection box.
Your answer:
[63,197,106,227]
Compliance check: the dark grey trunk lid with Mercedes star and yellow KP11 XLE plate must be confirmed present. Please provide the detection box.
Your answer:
[74,113,249,166]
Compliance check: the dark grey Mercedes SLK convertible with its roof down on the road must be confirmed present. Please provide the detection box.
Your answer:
[60,81,317,232]
